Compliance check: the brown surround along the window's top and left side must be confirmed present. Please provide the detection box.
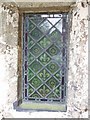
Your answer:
[16,3,75,111]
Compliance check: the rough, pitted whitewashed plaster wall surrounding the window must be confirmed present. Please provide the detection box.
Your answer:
[0,2,88,119]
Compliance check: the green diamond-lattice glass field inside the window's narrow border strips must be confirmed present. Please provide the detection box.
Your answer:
[25,15,66,101]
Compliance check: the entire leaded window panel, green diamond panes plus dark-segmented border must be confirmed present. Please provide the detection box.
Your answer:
[22,13,68,102]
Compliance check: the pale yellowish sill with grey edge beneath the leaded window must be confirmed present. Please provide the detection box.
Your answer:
[14,101,67,112]
